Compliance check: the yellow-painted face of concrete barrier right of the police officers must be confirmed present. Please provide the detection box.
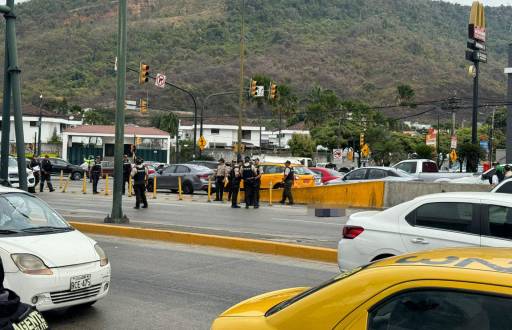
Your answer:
[260,181,384,208]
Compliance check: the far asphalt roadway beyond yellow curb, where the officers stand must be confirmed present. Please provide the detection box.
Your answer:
[38,183,353,248]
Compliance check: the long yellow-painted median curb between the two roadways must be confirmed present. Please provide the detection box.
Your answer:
[70,222,338,263]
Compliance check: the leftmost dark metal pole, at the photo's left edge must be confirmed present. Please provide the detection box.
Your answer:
[0,26,12,181]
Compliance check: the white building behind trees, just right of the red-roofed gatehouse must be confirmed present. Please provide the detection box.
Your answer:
[179,118,266,149]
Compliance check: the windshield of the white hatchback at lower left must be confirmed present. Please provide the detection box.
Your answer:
[0,193,72,235]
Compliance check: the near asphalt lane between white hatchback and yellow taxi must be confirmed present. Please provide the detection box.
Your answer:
[45,236,338,330]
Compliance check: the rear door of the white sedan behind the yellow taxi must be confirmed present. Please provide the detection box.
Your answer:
[399,197,480,252]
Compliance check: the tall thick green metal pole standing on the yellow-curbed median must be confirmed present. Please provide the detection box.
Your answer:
[105,0,129,223]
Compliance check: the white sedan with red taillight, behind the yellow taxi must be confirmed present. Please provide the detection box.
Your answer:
[338,192,512,270]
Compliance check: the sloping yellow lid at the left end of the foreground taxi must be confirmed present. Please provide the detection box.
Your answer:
[220,288,309,317]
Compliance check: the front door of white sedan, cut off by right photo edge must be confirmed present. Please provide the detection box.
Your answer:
[481,200,512,247]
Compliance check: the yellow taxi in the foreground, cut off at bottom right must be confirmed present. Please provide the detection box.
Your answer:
[212,248,512,330]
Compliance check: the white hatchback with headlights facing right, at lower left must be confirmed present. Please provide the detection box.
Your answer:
[0,187,110,311]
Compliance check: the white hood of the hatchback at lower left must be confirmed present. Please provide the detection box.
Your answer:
[0,230,100,268]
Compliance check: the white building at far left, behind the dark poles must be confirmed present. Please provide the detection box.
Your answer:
[0,105,82,154]
